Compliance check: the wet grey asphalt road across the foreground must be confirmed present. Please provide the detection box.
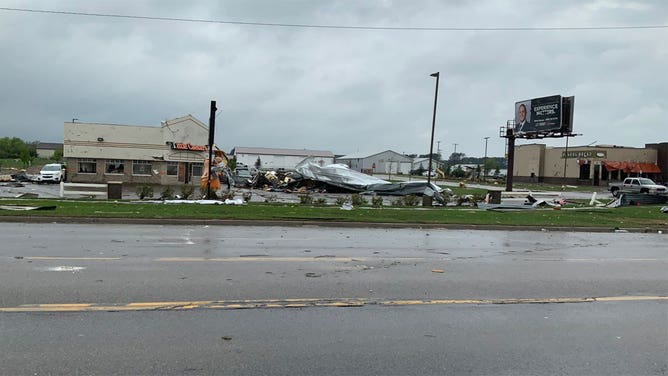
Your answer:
[0,223,668,375]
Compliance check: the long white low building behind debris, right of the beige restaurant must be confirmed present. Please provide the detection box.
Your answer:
[230,146,334,170]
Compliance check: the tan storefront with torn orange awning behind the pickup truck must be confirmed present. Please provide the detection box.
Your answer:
[513,142,668,185]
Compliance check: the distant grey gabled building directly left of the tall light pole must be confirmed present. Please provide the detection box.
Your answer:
[336,150,412,174]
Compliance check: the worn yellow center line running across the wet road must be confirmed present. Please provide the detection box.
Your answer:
[0,296,668,313]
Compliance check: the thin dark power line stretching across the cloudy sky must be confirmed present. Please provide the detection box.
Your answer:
[0,7,668,31]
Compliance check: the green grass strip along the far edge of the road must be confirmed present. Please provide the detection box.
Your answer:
[0,199,668,229]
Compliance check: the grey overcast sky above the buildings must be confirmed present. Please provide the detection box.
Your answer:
[0,0,668,156]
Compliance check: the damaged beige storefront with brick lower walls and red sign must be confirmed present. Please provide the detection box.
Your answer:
[63,115,209,185]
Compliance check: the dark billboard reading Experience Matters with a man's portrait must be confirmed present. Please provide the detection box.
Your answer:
[515,95,575,137]
